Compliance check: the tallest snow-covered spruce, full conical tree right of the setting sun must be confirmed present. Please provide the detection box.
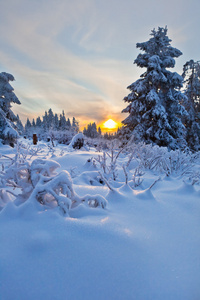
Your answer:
[122,27,187,149]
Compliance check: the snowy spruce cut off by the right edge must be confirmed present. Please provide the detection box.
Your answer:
[182,59,200,151]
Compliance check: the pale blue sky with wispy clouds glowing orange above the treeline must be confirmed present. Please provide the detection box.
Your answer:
[0,0,200,127]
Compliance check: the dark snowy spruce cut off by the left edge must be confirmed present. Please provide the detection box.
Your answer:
[0,72,21,145]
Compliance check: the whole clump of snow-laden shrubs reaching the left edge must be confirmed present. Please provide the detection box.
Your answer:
[0,144,107,214]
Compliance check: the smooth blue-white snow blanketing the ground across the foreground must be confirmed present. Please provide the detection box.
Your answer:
[0,139,200,300]
